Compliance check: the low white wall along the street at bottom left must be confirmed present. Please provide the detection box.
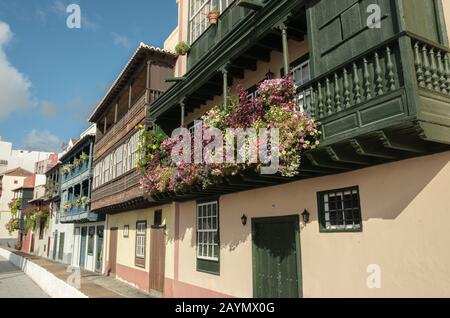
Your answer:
[0,247,89,298]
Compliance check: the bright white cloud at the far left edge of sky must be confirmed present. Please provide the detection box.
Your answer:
[0,21,32,120]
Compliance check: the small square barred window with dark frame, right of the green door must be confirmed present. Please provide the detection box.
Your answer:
[318,187,362,232]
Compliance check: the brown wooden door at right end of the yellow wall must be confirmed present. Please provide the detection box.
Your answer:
[150,226,166,293]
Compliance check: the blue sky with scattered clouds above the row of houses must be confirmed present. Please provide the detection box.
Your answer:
[0,0,177,151]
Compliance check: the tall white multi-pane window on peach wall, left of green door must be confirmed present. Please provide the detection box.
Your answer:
[196,201,220,262]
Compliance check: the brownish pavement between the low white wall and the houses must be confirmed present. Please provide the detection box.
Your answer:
[4,249,152,298]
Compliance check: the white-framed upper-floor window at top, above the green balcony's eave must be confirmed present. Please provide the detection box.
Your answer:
[189,0,234,43]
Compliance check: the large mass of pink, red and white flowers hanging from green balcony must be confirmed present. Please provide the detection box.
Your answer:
[138,78,320,194]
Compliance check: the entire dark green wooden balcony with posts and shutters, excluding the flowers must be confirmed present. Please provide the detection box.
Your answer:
[145,0,450,202]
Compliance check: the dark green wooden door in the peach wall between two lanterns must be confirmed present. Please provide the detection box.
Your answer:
[253,216,302,298]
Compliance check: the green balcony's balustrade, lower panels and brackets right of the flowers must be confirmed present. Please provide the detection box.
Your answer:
[298,33,450,172]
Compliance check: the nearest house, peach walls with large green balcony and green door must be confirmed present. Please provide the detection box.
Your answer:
[96,0,450,297]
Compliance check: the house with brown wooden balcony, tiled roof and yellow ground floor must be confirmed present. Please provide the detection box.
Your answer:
[90,43,176,291]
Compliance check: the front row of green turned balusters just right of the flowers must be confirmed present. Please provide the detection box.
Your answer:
[298,39,402,120]
